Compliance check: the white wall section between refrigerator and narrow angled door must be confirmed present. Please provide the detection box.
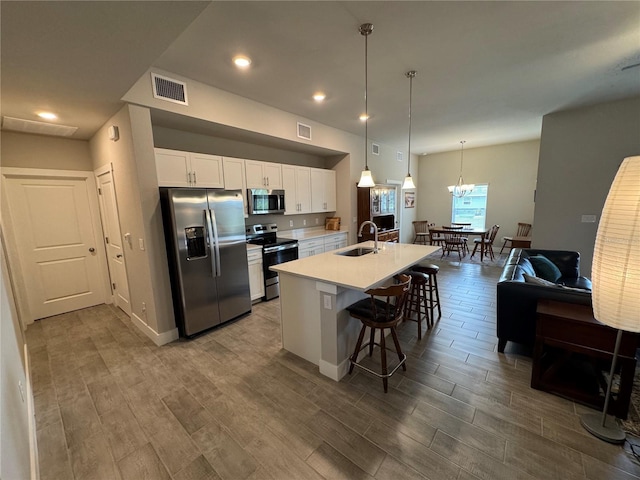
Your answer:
[89,105,177,343]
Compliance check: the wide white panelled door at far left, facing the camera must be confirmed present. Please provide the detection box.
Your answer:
[3,172,105,320]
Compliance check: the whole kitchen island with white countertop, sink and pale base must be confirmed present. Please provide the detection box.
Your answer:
[271,241,440,381]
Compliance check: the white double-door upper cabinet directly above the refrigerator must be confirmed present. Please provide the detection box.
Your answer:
[155,148,224,188]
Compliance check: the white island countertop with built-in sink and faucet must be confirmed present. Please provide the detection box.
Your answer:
[271,241,440,291]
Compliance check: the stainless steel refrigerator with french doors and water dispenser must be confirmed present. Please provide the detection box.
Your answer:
[160,188,251,337]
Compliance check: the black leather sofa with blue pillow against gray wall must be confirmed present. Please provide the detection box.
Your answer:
[497,248,591,352]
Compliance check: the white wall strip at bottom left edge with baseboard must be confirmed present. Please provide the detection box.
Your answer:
[0,229,33,480]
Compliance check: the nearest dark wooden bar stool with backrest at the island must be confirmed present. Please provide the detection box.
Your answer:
[346,274,411,393]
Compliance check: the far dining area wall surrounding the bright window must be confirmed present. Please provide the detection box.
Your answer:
[416,140,540,239]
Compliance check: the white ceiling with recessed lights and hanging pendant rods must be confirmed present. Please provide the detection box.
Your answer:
[0,1,640,154]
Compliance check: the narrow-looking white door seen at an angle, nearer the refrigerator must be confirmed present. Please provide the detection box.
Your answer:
[96,167,131,316]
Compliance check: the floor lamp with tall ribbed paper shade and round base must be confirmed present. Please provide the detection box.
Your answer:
[580,156,640,443]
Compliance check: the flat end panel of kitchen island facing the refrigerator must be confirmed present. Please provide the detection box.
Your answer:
[280,272,321,365]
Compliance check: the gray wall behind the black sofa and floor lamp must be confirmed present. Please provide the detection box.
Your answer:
[532,97,640,277]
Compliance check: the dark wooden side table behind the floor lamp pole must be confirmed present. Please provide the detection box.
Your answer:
[531,300,640,418]
